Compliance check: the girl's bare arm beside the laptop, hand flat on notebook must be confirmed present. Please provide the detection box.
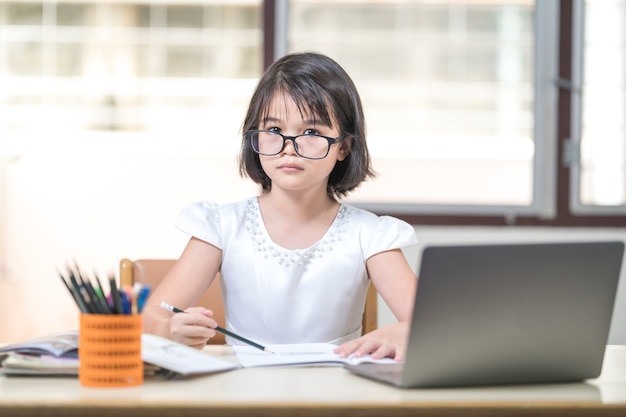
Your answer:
[336,249,417,361]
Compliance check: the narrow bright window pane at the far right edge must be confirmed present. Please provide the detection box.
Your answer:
[566,0,626,214]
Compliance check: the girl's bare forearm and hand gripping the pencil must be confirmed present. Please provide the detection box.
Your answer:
[143,237,221,348]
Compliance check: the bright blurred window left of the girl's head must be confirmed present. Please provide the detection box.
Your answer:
[0,0,262,141]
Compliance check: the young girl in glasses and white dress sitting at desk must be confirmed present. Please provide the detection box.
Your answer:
[144,53,417,360]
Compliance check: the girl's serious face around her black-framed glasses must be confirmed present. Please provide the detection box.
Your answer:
[259,93,350,195]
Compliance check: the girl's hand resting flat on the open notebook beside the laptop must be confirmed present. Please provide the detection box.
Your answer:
[335,322,409,362]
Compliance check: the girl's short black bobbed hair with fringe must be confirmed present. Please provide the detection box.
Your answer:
[239,52,375,199]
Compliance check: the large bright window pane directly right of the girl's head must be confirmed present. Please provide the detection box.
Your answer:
[287,0,556,216]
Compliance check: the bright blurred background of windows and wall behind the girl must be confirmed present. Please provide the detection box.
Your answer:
[0,0,626,343]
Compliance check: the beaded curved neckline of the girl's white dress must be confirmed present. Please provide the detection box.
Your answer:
[244,198,350,268]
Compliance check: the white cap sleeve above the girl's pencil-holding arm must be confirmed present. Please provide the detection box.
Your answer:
[176,201,223,249]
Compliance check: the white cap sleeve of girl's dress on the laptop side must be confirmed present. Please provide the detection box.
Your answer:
[364,216,417,259]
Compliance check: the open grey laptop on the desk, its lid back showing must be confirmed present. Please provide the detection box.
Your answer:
[346,242,624,388]
